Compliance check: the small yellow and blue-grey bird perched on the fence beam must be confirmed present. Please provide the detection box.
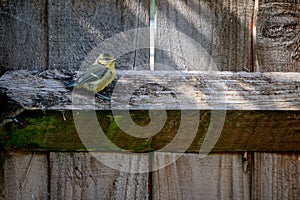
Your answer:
[64,53,116,100]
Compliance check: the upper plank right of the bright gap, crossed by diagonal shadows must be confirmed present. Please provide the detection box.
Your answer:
[155,0,253,71]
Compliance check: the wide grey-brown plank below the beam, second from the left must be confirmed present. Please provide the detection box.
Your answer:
[50,152,148,199]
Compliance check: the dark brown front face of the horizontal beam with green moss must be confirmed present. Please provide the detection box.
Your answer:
[0,110,300,153]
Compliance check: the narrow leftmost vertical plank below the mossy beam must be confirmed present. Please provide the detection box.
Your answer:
[1,152,49,199]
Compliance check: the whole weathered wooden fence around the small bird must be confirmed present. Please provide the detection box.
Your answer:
[0,0,300,199]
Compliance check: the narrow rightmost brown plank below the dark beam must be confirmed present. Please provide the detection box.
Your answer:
[253,152,300,199]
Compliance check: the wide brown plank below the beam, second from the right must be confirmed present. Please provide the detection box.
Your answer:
[152,154,251,199]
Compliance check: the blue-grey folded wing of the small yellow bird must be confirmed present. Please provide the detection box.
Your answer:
[76,65,107,85]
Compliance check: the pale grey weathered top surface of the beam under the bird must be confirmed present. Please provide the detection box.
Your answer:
[0,70,300,110]
